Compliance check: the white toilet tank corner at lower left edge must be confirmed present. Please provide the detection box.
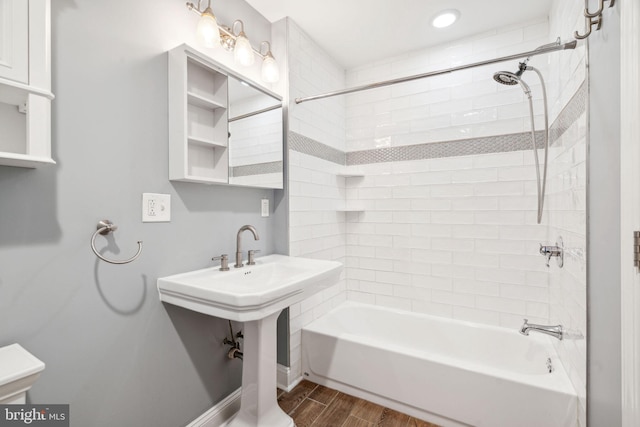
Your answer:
[0,344,44,405]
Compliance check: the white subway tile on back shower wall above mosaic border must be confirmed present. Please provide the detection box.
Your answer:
[346,19,552,155]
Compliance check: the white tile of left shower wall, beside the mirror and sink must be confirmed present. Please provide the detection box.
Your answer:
[287,19,346,378]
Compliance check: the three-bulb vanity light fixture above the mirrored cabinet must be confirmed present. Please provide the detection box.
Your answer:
[182,0,280,83]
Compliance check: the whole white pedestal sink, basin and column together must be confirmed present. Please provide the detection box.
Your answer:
[158,255,342,427]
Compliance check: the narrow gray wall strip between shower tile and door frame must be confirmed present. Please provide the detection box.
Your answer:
[587,7,631,427]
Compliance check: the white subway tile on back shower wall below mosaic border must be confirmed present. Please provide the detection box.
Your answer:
[346,151,549,328]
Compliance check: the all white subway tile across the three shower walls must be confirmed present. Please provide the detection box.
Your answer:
[290,0,586,426]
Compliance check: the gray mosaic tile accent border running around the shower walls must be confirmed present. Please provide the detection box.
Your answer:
[289,82,587,165]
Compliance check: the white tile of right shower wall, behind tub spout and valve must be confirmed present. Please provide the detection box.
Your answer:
[546,0,588,427]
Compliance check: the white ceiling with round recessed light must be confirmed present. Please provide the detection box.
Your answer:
[247,0,552,69]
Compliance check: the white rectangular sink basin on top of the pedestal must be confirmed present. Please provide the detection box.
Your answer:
[158,255,342,322]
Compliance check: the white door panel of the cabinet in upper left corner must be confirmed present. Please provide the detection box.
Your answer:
[0,0,29,83]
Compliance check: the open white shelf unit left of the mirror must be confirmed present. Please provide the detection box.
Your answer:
[168,45,229,184]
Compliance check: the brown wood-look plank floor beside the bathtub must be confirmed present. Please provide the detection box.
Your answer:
[278,380,439,427]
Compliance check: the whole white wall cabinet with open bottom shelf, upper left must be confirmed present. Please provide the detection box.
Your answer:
[0,0,55,167]
